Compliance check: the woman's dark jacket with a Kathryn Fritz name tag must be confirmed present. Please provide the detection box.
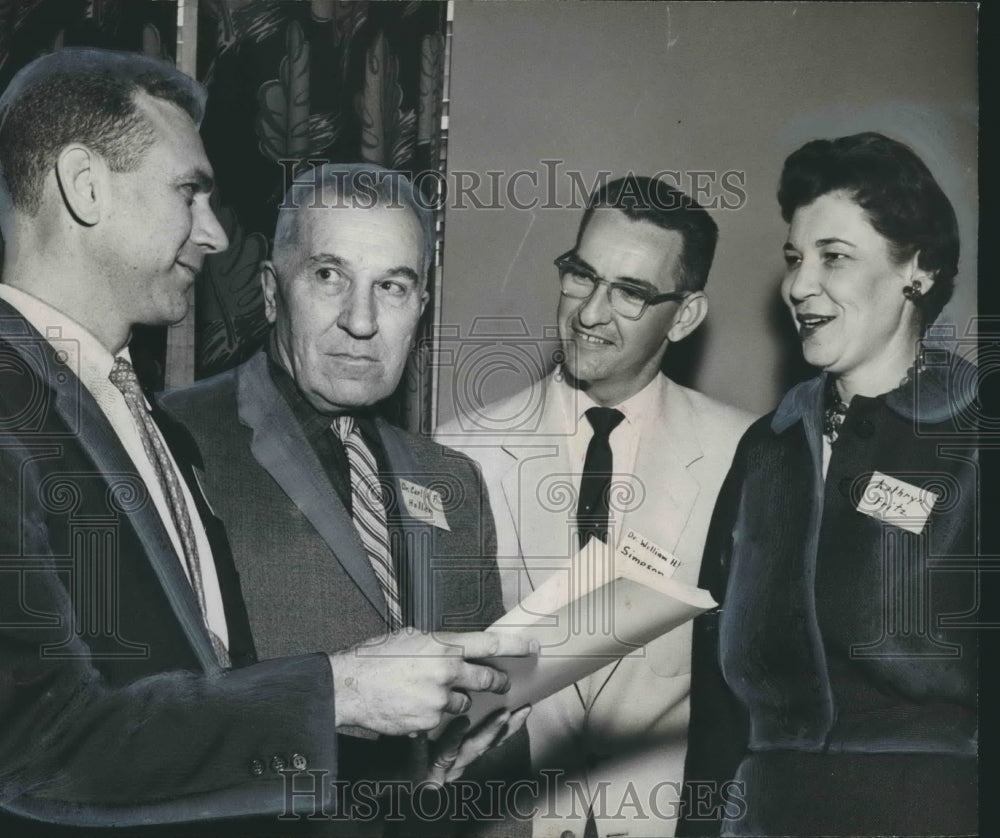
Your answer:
[679,352,979,835]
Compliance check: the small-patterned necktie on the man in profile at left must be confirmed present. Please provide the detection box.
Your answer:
[108,358,230,667]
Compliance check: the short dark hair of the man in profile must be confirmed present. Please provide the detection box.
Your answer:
[0,47,206,215]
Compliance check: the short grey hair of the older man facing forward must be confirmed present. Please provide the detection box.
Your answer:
[272,163,435,279]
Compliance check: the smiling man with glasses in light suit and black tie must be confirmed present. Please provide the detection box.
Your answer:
[437,176,752,838]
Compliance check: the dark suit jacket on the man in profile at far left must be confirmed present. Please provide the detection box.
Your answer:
[0,301,336,834]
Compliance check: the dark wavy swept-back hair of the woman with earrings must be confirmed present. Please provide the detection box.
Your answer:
[778,131,959,326]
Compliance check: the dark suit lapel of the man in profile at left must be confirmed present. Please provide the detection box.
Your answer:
[0,300,219,671]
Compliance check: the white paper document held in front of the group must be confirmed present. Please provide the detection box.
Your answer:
[450,531,716,724]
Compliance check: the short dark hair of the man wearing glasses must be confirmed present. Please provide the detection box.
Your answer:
[576,174,719,291]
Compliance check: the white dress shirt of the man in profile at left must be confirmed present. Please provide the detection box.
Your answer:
[0,284,229,648]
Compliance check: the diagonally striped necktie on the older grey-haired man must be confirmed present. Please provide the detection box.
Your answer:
[331,416,403,631]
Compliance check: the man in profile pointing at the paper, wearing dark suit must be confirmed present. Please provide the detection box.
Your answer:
[0,50,527,836]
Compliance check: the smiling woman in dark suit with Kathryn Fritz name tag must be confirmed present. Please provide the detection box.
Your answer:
[681,133,978,835]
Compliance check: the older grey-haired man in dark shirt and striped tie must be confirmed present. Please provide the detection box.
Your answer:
[163,164,529,835]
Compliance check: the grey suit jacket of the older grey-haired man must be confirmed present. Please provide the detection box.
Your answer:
[162,353,528,828]
